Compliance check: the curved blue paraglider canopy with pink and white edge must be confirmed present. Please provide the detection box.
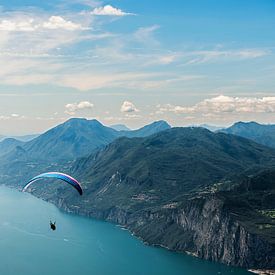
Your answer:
[23,172,83,195]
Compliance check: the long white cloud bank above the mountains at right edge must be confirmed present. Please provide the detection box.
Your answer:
[157,95,275,116]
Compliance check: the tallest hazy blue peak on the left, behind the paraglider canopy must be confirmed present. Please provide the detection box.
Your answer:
[23,118,118,161]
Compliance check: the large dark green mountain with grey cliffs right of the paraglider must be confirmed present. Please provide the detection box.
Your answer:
[27,127,275,268]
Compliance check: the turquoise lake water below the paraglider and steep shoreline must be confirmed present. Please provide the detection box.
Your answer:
[0,187,250,275]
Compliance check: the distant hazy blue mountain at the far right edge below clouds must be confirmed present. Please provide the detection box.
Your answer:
[221,122,275,148]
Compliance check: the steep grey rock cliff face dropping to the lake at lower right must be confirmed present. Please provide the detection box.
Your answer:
[171,196,275,268]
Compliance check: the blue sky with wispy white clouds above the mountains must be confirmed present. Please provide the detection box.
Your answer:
[0,0,275,135]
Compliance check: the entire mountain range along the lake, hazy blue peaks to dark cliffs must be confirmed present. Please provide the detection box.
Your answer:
[0,119,275,268]
